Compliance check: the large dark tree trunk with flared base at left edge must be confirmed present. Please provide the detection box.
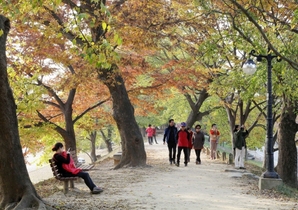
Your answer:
[0,15,45,209]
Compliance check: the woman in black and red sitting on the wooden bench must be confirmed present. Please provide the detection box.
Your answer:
[52,142,103,194]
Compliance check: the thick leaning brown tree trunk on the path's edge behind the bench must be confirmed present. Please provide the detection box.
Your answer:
[99,65,146,169]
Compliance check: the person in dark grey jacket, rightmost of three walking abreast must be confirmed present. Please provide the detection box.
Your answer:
[192,125,205,164]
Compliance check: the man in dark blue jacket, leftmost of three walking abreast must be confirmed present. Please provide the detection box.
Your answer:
[163,119,177,164]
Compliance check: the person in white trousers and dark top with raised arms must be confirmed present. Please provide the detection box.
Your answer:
[234,125,248,169]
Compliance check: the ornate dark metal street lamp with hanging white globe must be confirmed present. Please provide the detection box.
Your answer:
[243,48,281,178]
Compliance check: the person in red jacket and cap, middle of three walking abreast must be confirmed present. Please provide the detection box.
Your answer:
[176,122,190,167]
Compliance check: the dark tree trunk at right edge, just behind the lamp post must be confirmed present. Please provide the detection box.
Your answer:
[276,102,298,187]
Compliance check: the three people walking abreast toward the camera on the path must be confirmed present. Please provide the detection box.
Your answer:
[163,119,205,166]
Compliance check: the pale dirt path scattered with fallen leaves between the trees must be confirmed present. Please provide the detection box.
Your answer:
[45,138,298,210]
